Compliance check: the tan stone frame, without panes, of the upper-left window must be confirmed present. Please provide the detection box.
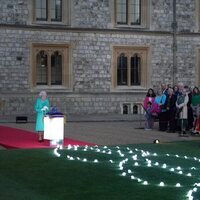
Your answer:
[32,0,71,25]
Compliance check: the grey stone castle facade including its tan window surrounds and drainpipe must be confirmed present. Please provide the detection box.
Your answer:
[0,0,200,116]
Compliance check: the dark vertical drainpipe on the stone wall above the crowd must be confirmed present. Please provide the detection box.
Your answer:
[172,0,178,85]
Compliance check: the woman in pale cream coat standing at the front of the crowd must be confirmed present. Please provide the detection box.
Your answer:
[176,89,189,136]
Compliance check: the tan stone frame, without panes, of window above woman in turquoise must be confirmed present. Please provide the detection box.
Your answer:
[31,43,72,89]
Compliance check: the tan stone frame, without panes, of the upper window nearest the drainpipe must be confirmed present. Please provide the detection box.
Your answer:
[114,0,150,28]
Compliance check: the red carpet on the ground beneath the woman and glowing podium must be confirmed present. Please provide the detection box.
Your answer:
[0,126,94,149]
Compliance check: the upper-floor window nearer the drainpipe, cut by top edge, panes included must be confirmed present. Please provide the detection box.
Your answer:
[115,0,149,27]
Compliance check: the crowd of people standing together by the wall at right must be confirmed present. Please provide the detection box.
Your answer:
[143,83,200,136]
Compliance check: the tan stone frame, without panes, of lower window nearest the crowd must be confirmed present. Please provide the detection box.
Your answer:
[112,46,151,91]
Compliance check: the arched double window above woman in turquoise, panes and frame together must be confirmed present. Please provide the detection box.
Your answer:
[32,44,70,87]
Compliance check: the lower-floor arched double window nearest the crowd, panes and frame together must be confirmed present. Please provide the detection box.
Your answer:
[112,47,149,88]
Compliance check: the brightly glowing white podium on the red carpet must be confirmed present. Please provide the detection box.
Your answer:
[44,115,64,146]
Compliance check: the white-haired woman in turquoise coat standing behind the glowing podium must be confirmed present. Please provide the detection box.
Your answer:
[34,91,49,142]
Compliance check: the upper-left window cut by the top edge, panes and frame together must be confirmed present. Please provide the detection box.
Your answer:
[33,0,70,24]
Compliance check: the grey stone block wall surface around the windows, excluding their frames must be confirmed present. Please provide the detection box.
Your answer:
[0,0,200,116]
